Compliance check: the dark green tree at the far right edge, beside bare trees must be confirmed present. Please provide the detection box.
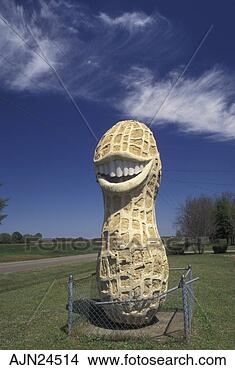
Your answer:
[215,195,233,244]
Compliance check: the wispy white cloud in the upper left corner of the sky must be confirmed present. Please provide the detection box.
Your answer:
[0,1,64,91]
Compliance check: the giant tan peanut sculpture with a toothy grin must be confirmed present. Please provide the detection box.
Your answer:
[94,120,169,325]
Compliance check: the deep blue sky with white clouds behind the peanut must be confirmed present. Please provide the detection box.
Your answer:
[0,0,235,237]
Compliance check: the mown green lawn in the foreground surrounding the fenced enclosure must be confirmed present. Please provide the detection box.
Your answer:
[0,254,235,349]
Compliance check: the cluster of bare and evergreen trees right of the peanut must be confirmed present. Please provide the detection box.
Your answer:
[175,193,235,245]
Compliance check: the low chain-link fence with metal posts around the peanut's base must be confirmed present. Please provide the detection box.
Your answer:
[67,266,199,340]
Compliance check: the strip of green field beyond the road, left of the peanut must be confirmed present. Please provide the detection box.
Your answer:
[0,244,98,263]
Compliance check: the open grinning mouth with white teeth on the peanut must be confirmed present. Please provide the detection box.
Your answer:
[95,159,149,183]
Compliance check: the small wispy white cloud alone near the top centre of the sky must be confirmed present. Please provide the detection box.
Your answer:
[99,12,153,32]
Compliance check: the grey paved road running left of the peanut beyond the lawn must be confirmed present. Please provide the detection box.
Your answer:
[0,253,97,273]
